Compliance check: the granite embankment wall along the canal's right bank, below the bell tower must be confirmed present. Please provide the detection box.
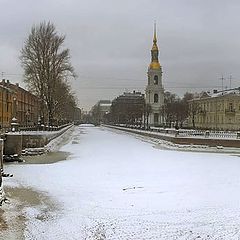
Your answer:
[104,125,240,148]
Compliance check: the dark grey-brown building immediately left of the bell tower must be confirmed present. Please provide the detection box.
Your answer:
[111,91,145,124]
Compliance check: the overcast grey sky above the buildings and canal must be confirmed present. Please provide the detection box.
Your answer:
[0,0,240,109]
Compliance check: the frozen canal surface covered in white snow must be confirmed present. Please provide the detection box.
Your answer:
[2,127,240,240]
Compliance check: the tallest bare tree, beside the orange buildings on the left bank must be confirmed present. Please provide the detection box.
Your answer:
[20,22,76,124]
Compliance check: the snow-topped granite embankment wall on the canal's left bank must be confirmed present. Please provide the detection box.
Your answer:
[4,125,73,155]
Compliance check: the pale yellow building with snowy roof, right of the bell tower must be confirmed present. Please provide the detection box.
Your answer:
[188,88,240,130]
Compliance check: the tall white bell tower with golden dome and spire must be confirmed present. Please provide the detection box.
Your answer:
[145,24,164,126]
